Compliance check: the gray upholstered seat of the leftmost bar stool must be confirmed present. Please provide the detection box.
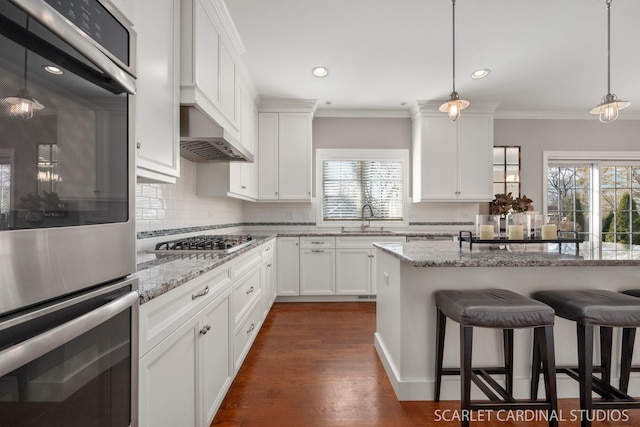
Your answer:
[436,289,554,329]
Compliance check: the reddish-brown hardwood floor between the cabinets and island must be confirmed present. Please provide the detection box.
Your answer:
[211,303,640,427]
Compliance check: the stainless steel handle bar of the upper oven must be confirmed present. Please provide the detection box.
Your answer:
[11,0,136,95]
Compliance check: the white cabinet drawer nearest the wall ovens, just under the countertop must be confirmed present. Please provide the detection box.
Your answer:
[139,267,231,356]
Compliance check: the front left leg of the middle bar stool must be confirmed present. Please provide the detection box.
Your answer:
[576,323,593,427]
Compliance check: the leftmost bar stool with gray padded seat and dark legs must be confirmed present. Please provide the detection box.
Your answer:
[434,289,558,427]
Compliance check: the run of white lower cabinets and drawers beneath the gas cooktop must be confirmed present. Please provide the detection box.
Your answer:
[138,240,275,427]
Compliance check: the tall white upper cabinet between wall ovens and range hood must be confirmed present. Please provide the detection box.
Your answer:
[134,0,180,183]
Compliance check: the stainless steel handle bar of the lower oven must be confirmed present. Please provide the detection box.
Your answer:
[0,291,139,377]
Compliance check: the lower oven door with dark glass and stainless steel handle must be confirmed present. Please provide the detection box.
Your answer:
[0,280,138,427]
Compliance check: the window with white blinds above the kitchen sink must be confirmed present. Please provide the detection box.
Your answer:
[317,150,408,225]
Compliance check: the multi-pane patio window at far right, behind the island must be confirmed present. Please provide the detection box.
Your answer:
[544,153,640,257]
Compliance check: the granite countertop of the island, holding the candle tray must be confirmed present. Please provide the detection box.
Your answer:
[375,241,640,267]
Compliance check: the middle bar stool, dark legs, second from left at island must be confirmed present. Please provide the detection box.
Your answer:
[532,290,640,427]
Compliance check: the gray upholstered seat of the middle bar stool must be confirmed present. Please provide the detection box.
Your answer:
[533,289,640,327]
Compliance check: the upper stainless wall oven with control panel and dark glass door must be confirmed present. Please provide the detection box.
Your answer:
[0,0,135,315]
